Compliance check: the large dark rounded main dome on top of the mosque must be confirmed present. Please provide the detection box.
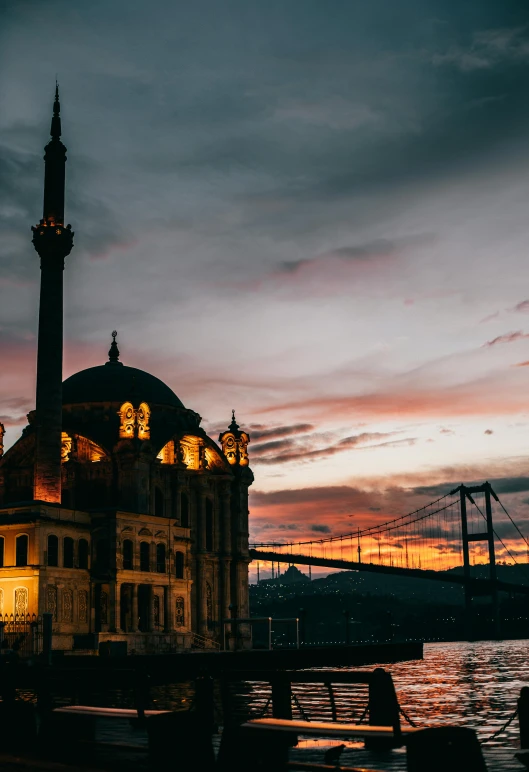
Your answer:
[62,362,184,408]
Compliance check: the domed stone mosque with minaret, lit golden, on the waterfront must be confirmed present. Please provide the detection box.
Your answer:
[0,88,253,654]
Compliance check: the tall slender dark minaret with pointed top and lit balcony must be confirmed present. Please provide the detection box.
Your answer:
[31,85,73,504]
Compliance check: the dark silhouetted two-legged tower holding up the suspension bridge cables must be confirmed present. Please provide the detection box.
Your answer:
[451,482,500,641]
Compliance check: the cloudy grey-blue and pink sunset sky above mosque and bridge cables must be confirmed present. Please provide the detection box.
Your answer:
[0,0,529,568]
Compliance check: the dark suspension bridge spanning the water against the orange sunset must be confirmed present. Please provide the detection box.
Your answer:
[250,482,529,634]
